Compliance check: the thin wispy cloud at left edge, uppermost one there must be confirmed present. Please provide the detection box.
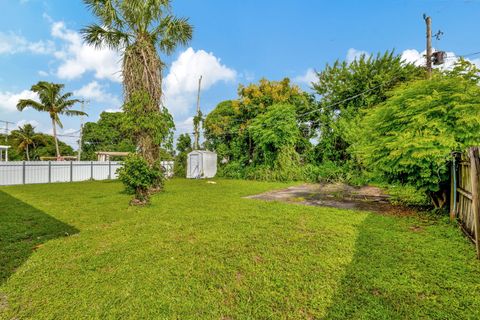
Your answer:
[0,32,54,54]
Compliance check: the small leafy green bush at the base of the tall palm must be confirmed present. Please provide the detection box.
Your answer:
[117,154,163,204]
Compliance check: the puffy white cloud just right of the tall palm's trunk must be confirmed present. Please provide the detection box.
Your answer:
[164,48,237,115]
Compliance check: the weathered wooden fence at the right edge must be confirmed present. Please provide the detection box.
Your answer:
[450,147,480,258]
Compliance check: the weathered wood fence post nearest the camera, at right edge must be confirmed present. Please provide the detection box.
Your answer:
[468,147,480,259]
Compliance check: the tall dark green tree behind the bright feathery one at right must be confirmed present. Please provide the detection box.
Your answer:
[313,51,423,162]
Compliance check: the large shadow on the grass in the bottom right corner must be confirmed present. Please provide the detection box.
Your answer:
[325,214,480,319]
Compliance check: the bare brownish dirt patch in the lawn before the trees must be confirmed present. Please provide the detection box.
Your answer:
[247,183,414,215]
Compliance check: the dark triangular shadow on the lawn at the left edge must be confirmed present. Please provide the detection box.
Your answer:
[0,191,78,285]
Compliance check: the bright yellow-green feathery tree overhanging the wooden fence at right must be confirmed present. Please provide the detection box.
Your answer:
[352,76,480,207]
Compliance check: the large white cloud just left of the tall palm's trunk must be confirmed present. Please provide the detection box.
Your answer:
[51,22,121,82]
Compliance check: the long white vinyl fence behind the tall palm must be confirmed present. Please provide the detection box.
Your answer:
[0,161,173,186]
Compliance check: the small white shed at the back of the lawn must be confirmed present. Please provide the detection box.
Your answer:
[187,150,217,179]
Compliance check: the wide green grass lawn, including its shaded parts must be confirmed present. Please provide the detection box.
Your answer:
[0,179,480,319]
